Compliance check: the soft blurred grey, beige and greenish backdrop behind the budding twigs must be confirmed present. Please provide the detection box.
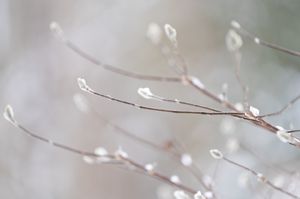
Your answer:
[0,0,300,199]
